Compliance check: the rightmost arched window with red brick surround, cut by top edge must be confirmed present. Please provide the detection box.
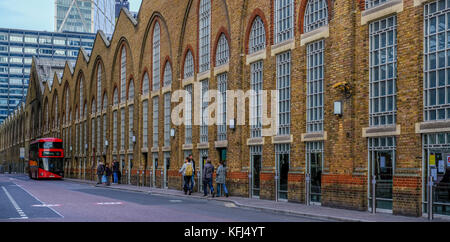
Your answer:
[304,0,328,33]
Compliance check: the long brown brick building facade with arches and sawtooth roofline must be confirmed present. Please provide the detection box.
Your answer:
[0,0,450,216]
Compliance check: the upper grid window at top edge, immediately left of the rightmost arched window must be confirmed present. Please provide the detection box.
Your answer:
[274,0,294,43]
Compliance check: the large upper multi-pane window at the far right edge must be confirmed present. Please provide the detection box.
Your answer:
[424,1,450,121]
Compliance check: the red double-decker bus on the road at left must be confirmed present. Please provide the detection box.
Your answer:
[28,138,64,179]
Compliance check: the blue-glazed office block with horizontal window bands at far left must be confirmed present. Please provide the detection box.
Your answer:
[0,28,95,123]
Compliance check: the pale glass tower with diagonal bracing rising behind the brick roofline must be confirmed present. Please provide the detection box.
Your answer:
[55,0,115,36]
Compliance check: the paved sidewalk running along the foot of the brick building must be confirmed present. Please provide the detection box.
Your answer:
[64,178,450,222]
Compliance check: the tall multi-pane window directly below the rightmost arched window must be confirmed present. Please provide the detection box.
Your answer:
[306,40,325,132]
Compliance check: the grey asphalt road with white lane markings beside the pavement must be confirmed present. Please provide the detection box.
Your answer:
[0,174,330,222]
